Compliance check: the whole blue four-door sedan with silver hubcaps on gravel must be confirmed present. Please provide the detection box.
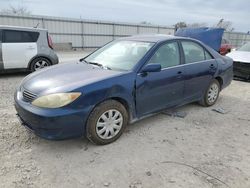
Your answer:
[15,35,233,144]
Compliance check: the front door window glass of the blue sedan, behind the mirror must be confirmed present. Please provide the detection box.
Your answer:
[148,42,180,69]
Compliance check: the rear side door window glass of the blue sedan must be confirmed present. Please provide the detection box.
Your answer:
[182,41,206,63]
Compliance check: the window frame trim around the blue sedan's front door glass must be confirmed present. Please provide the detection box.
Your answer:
[145,39,183,71]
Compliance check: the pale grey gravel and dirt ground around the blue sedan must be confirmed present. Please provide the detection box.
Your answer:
[0,52,250,188]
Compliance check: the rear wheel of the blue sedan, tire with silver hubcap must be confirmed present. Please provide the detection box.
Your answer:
[200,79,221,107]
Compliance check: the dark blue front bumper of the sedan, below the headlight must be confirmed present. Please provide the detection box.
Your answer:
[15,90,89,140]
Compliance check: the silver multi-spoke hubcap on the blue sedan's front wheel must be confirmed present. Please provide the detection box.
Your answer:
[96,109,123,140]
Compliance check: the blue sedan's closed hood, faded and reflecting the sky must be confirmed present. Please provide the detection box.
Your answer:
[21,62,122,95]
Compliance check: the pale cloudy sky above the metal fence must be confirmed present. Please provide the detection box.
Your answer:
[0,0,250,32]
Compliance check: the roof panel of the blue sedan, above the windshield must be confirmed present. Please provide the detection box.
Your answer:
[120,34,184,42]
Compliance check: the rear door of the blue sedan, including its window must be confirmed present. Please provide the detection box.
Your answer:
[181,40,218,101]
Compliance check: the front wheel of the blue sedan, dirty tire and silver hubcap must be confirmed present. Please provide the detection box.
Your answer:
[86,100,129,145]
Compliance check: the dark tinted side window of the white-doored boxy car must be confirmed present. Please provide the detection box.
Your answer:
[3,30,39,43]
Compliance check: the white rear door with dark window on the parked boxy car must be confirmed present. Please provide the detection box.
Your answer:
[2,30,39,69]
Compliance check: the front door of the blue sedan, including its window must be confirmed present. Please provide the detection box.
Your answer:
[136,42,184,117]
